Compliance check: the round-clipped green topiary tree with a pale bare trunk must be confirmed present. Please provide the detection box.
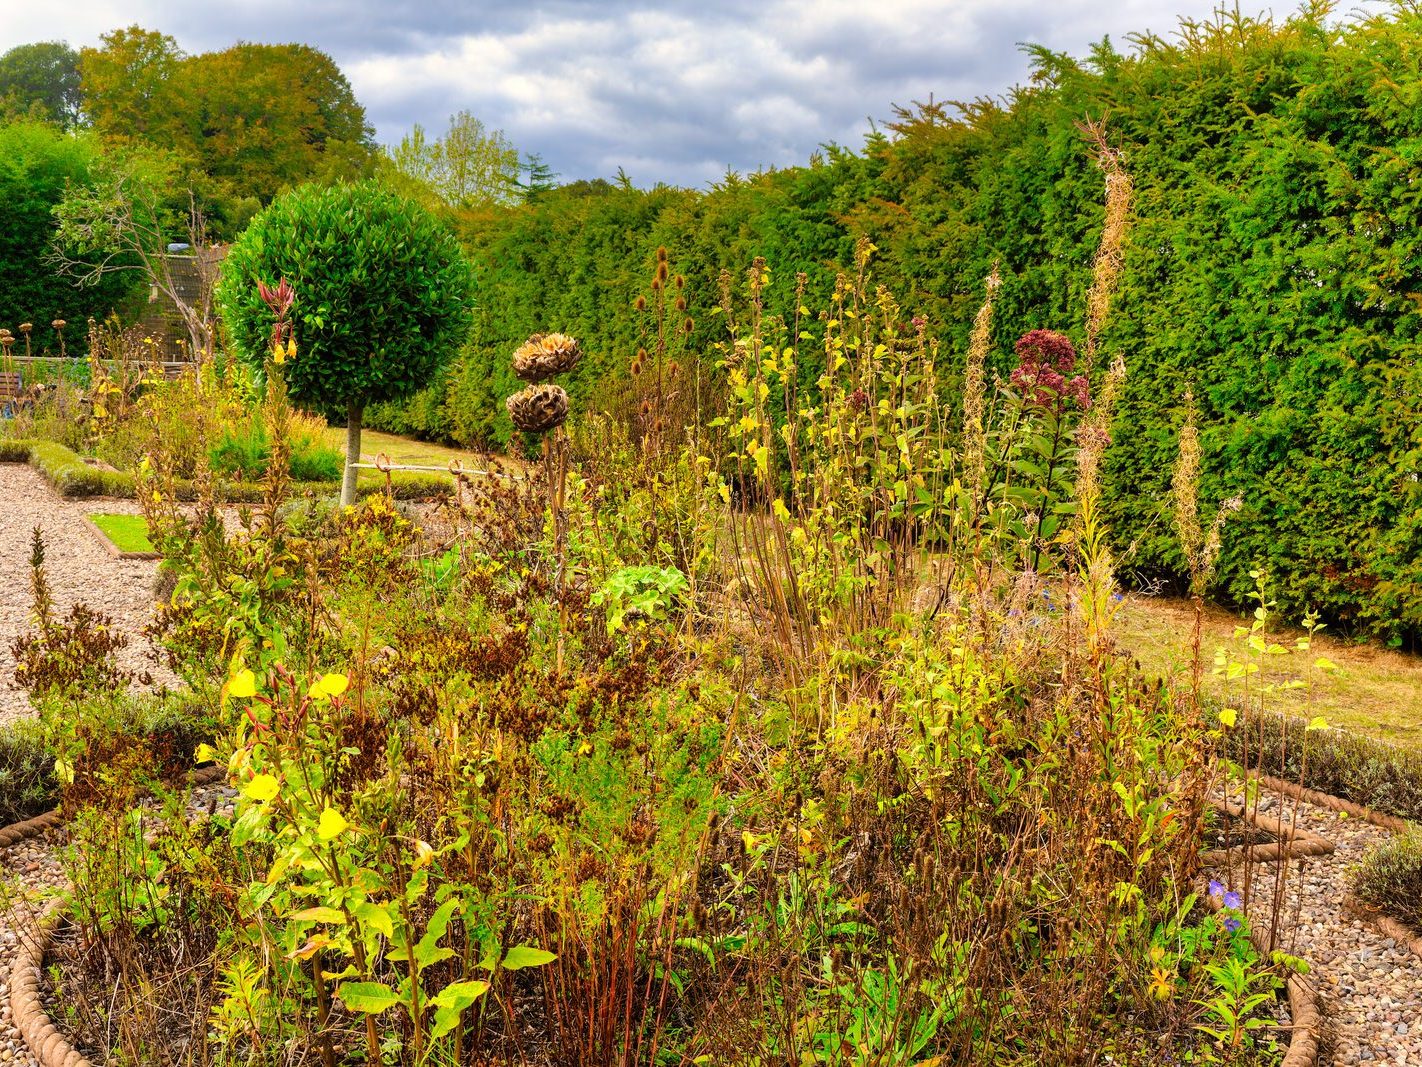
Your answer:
[218,182,474,504]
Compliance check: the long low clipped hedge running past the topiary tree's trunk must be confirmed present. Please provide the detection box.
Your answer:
[0,440,454,504]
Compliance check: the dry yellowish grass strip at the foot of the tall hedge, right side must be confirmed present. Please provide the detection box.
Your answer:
[1115,596,1422,750]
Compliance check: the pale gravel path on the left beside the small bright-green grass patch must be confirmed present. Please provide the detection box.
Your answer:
[0,464,178,728]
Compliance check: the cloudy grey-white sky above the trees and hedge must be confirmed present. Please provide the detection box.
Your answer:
[0,0,1293,185]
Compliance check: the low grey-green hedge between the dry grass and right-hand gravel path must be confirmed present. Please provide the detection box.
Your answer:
[1226,711,1422,822]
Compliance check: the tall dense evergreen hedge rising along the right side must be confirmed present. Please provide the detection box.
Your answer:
[370,6,1422,642]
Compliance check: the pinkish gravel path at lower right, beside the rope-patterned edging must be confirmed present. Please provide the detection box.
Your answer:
[1214,795,1422,1067]
